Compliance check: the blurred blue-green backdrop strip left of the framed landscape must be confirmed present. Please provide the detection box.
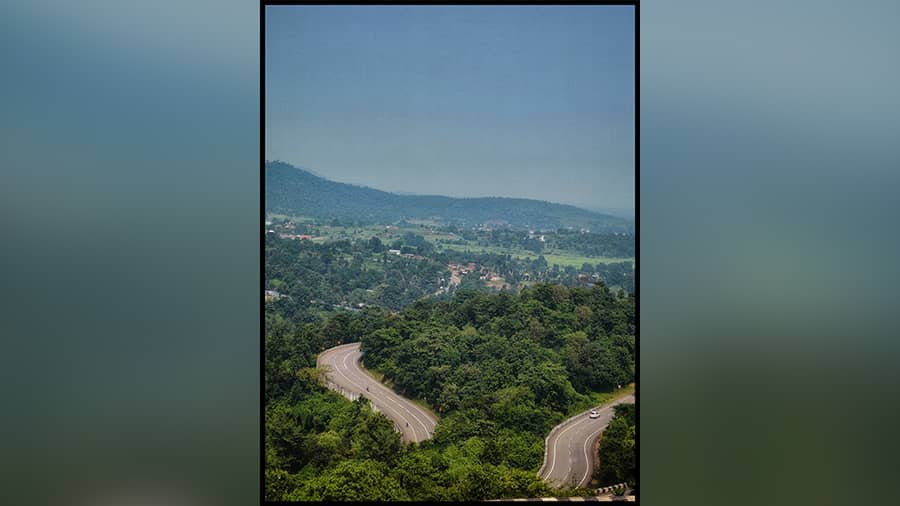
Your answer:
[0,0,261,505]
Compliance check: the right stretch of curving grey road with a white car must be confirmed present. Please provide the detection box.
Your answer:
[538,394,634,487]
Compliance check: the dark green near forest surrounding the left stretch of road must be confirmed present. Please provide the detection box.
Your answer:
[265,284,635,501]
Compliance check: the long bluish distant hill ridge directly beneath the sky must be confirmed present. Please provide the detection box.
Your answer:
[265,162,634,233]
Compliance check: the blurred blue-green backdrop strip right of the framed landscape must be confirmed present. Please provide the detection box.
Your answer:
[639,0,900,505]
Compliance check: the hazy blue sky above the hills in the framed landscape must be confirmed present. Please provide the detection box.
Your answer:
[265,6,635,208]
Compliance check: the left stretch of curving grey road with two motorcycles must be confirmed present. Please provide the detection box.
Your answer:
[316,343,437,443]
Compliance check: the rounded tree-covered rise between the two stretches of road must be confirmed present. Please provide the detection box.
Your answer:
[362,284,634,414]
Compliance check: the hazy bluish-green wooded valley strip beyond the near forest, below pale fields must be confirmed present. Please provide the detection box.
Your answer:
[265,234,634,322]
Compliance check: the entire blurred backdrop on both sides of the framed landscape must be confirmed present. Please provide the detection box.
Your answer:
[0,0,900,505]
